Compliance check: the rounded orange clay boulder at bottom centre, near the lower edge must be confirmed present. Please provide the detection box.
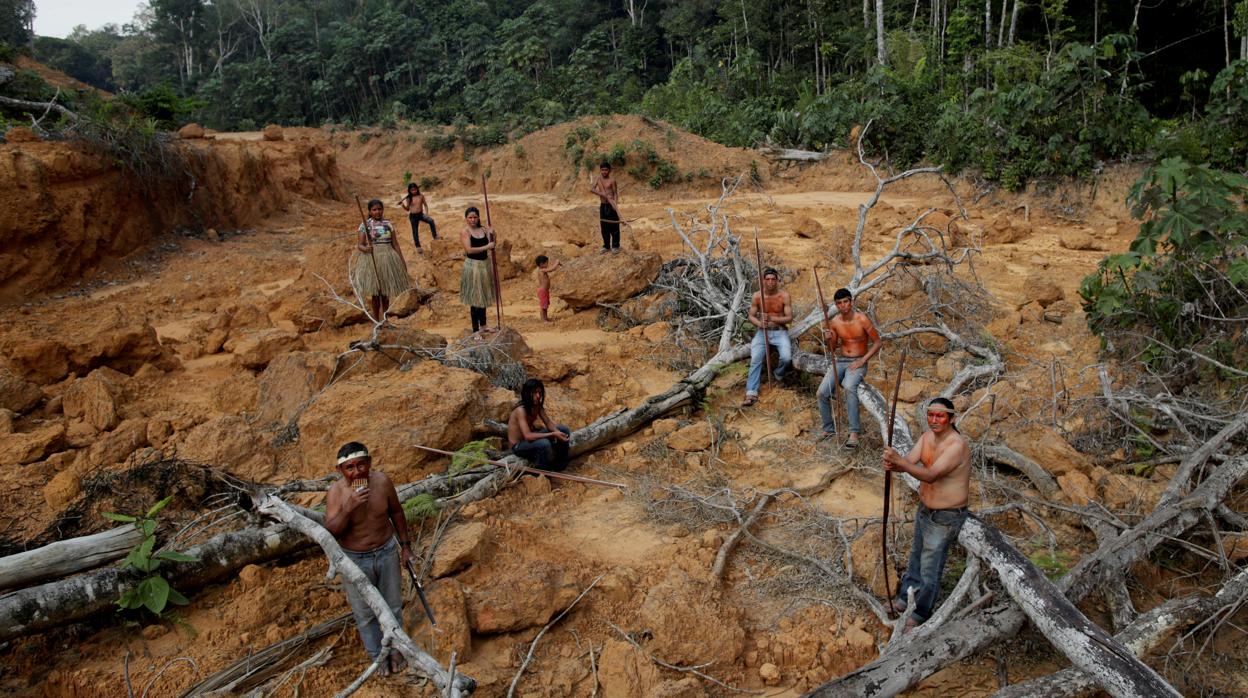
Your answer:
[638,566,745,667]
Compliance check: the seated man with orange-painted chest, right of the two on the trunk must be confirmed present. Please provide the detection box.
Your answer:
[815,288,882,448]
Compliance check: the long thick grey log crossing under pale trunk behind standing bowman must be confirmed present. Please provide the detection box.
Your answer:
[809,456,1248,697]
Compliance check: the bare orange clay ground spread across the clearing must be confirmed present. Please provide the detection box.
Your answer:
[0,116,1243,698]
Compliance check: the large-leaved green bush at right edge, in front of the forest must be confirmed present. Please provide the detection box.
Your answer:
[1080,157,1248,361]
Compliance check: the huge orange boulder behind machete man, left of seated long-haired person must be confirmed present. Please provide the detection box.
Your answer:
[297,361,489,482]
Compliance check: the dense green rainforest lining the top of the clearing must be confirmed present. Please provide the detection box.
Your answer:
[0,0,1248,187]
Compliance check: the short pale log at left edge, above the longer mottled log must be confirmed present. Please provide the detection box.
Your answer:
[0,523,144,589]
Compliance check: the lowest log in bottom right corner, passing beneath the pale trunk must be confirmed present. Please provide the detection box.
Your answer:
[992,568,1248,698]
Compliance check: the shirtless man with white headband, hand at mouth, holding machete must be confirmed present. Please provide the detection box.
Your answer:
[324,441,412,676]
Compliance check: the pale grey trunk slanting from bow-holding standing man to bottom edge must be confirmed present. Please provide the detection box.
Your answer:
[957,517,1179,698]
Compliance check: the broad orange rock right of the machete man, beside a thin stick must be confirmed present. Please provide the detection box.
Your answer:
[468,561,580,634]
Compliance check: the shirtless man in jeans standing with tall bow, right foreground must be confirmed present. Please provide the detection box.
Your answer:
[884,397,971,629]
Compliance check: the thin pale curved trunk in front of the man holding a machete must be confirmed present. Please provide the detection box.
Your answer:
[258,496,477,698]
